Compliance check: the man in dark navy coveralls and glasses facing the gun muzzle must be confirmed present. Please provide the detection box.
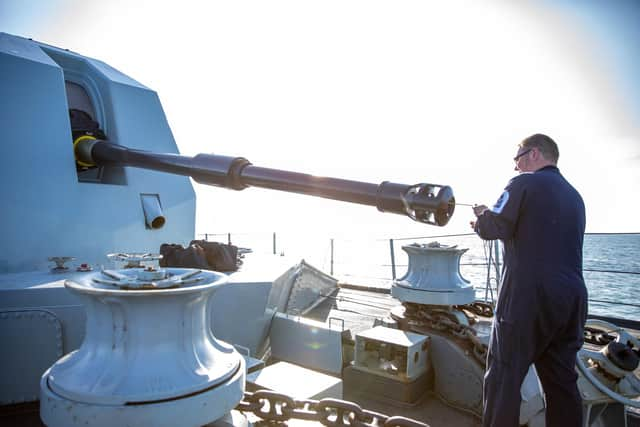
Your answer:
[471,134,587,427]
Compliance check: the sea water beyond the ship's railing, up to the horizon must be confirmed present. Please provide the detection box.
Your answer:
[202,232,640,320]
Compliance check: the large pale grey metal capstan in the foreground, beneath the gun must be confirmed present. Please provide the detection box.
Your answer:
[41,269,245,426]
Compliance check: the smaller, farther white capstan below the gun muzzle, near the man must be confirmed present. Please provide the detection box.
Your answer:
[391,242,475,305]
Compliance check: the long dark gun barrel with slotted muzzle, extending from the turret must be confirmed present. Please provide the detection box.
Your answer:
[75,138,455,226]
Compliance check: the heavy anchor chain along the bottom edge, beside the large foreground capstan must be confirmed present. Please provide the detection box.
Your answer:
[236,390,429,427]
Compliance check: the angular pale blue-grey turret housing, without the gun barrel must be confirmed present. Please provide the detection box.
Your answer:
[0,33,195,273]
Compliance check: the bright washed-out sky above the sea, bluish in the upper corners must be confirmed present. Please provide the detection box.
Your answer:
[0,0,640,237]
